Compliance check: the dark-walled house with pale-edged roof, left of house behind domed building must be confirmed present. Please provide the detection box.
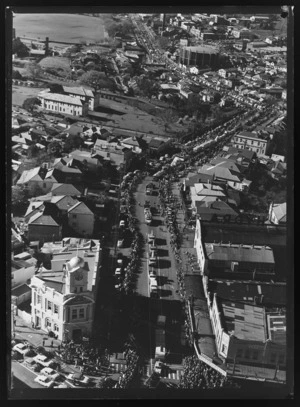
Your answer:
[27,212,62,242]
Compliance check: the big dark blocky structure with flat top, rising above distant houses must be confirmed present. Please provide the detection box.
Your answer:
[179,45,219,68]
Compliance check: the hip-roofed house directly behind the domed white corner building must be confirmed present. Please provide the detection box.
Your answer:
[68,202,95,237]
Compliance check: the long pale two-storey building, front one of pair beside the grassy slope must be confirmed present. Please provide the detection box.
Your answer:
[38,91,89,116]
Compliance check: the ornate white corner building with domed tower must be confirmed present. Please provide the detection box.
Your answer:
[30,239,100,342]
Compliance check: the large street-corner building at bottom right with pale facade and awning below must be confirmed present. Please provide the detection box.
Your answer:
[209,294,286,379]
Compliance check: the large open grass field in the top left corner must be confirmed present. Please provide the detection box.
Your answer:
[13,13,105,43]
